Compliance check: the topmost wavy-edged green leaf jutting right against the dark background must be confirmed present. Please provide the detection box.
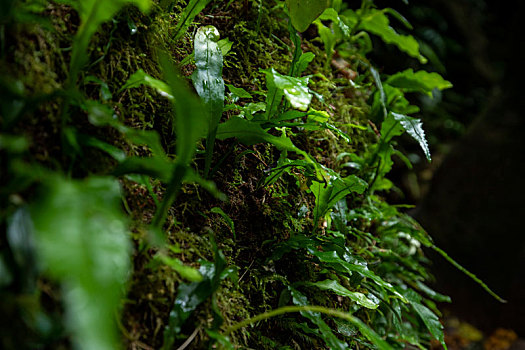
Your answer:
[359,9,427,63]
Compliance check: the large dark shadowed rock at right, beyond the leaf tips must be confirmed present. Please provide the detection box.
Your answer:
[417,83,525,337]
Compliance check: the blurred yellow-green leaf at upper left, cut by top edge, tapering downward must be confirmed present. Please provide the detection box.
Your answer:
[64,0,151,84]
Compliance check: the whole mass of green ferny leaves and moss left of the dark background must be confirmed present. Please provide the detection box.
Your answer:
[0,0,504,350]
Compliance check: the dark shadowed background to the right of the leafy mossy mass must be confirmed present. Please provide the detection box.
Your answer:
[375,0,525,337]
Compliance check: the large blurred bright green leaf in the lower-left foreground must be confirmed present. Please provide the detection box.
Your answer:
[32,177,131,350]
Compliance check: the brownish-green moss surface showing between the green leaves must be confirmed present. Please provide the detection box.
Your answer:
[0,1,456,349]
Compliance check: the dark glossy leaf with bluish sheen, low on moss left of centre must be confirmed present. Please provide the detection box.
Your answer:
[162,246,226,350]
